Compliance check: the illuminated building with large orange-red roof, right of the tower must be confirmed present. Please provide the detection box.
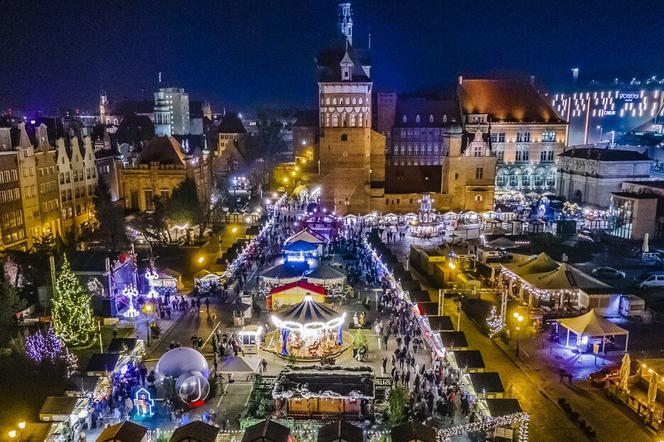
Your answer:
[457,78,567,193]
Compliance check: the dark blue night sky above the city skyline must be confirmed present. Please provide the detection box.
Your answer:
[0,0,664,111]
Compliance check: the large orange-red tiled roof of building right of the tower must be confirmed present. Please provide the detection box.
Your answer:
[459,79,565,123]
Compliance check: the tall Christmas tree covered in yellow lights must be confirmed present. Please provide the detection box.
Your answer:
[51,255,95,347]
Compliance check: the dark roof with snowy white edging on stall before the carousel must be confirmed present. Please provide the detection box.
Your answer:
[272,365,374,399]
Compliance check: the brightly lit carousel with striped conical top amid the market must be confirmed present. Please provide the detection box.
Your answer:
[265,295,349,360]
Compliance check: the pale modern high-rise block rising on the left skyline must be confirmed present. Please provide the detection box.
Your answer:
[154,87,190,137]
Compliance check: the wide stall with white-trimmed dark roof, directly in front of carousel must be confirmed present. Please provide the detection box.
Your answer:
[272,365,375,419]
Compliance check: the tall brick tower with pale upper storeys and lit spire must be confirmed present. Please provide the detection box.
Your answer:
[316,3,378,214]
